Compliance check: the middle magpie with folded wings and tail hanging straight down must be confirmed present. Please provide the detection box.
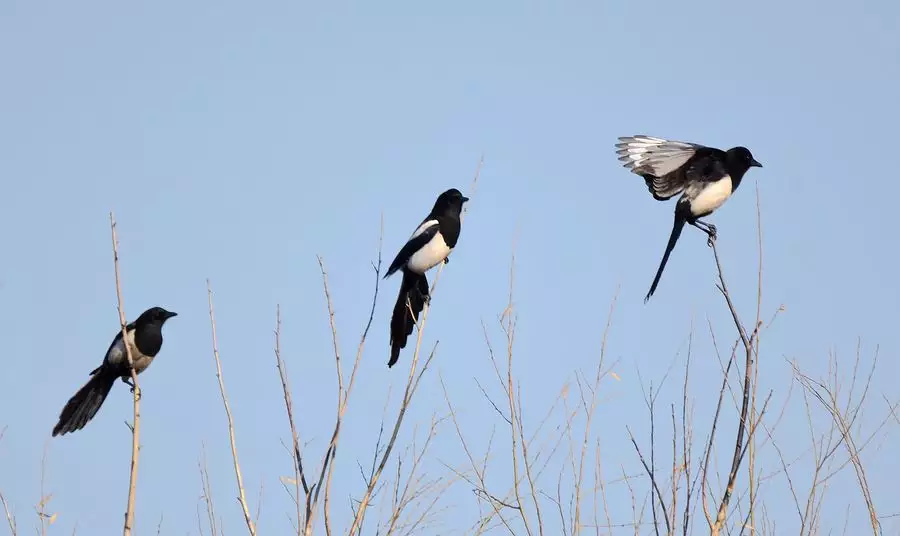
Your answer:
[384,188,469,368]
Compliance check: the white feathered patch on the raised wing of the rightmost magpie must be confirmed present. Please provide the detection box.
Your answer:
[616,135,699,177]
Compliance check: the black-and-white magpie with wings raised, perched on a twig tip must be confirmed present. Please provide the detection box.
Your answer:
[616,135,762,303]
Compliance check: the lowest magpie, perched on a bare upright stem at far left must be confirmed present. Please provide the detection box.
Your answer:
[53,307,178,437]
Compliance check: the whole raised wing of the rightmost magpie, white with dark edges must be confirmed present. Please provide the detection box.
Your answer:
[616,135,706,201]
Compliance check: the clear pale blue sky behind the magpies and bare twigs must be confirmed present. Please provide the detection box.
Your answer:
[0,0,900,535]
